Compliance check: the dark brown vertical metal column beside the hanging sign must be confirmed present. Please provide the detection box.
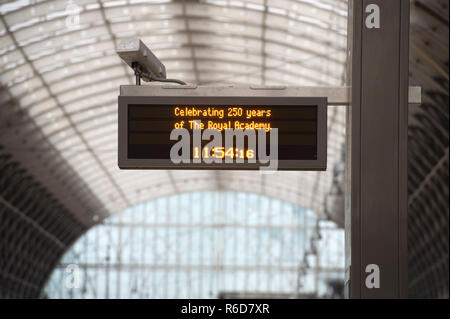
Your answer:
[345,0,410,298]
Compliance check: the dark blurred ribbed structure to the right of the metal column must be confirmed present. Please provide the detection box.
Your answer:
[408,0,449,298]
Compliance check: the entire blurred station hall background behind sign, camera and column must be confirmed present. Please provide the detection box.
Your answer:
[0,0,449,298]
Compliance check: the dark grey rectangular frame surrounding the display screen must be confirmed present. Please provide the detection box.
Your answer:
[118,96,328,171]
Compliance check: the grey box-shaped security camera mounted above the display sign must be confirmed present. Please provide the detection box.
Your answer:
[116,38,166,81]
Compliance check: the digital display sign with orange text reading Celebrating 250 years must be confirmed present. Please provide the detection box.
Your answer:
[119,96,327,170]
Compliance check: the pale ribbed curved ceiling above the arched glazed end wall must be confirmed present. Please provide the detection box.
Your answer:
[0,0,347,224]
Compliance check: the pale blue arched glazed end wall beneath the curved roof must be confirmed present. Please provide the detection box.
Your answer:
[46,192,344,298]
